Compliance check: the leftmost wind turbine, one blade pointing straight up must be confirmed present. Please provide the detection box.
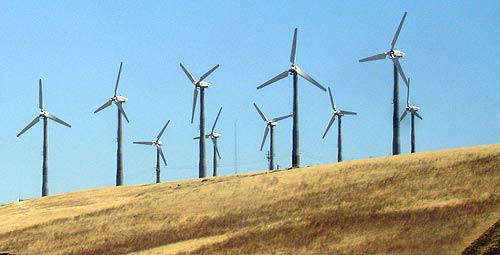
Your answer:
[16,79,71,197]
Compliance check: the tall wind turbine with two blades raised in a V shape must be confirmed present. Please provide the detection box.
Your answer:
[180,64,219,178]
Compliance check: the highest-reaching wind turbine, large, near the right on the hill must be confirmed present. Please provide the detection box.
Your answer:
[359,12,408,155]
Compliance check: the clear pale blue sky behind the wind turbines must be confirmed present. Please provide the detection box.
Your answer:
[0,1,500,204]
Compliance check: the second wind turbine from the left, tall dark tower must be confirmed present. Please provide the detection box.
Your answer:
[94,62,129,186]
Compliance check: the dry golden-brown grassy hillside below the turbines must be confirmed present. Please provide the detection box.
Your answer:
[0,145,500,254]
